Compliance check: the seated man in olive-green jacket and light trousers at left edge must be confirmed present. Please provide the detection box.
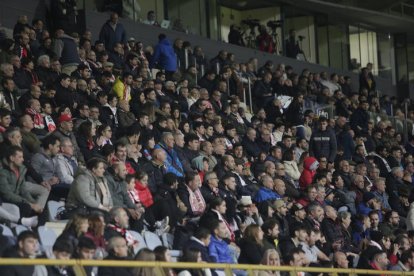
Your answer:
[0,146,49,217]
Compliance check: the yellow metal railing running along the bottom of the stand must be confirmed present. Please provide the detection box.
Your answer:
[0,258,414,276]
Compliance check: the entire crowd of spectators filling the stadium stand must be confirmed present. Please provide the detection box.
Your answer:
[0,7,414,275]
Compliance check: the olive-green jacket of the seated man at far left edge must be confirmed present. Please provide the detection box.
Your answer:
[0,160,31,204]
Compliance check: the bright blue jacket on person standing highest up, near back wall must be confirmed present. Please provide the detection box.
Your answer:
[150,38,177,72]
